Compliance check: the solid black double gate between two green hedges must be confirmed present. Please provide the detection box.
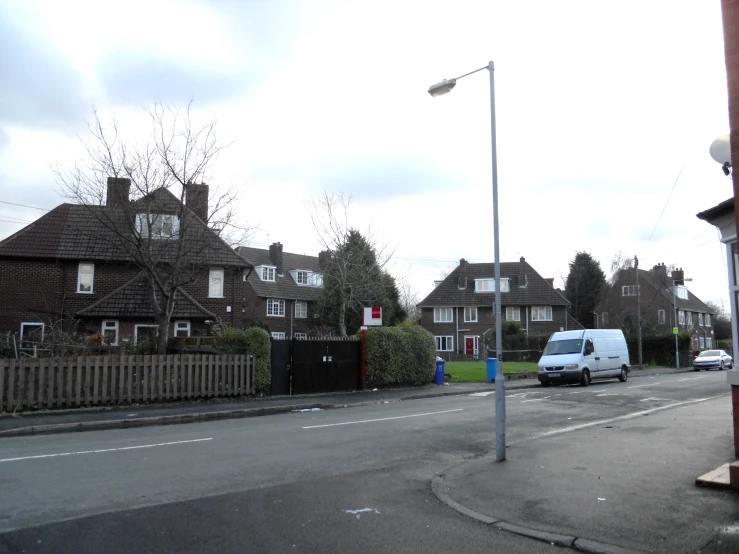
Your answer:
[272,334,362,395]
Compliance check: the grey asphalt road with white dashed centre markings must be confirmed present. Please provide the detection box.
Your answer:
[0,372,728,552]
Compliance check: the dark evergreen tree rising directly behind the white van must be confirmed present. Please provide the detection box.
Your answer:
[565,252,606,329]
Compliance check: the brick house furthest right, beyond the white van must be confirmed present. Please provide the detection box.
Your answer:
[595,264,714,350]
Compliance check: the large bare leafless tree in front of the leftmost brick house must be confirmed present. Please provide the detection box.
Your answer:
[52,103,251,353]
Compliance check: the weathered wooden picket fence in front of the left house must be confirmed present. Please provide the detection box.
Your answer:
[0,354,256,412]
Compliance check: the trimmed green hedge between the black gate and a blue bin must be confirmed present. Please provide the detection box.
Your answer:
[365,325,436,387]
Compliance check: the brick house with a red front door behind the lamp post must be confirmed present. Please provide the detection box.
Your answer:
[418,257,583,359]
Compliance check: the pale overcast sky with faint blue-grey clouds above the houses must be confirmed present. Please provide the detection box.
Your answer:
[0,0,732,309]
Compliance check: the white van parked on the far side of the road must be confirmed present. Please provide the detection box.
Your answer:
[537,329,631,387]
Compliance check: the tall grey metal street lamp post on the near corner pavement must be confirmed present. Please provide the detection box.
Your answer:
[429,62,505,462]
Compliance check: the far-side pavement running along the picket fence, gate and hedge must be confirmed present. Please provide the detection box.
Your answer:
[0,367,692,438]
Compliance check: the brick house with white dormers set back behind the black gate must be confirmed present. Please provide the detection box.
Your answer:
[237,242,325,339]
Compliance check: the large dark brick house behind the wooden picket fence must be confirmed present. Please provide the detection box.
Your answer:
[0,178,250,345]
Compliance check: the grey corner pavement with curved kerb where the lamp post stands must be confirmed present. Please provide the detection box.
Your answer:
[432,387,739,553]
